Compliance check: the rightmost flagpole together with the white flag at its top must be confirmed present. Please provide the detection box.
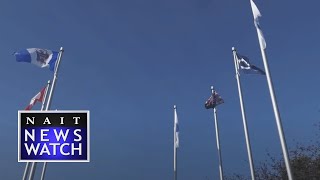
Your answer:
[250,0,293,180]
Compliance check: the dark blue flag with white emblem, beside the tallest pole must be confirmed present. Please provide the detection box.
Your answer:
[237,53,266,75]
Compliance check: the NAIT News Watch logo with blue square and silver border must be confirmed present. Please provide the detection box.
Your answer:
[18,111,90,162]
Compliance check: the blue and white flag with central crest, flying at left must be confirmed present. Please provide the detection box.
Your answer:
[14,48,59,71]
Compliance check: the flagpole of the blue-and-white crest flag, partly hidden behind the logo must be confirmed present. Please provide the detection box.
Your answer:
[40,47,64,180]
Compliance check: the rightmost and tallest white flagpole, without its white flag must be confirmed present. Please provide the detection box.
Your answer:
[256,28,293,180]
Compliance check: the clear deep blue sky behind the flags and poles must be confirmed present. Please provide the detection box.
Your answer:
[0,0,320,180]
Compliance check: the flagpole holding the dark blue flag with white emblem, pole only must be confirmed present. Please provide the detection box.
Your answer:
[232,47,255,180]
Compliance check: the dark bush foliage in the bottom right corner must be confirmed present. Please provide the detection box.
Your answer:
[225,124,320,180]
